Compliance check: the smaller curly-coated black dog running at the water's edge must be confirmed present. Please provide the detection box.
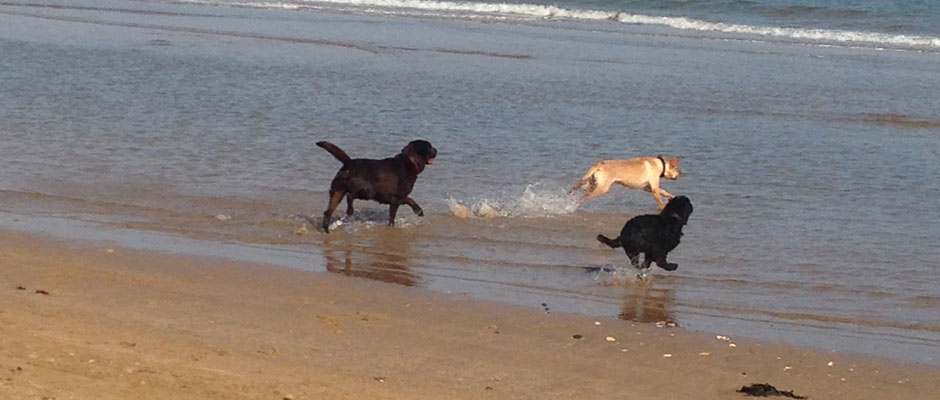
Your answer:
[597,196,692,271]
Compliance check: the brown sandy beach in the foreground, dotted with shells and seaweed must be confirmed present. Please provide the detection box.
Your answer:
[0,232,940,400]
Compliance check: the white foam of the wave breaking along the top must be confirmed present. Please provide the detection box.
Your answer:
[182,0,940,50]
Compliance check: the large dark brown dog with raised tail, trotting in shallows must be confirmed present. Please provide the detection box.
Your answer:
[317,140,437,232]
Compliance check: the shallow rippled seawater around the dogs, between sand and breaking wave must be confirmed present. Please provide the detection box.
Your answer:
[0,1,940,364]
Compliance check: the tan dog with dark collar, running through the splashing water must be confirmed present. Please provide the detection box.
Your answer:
[568,154,680,210]
